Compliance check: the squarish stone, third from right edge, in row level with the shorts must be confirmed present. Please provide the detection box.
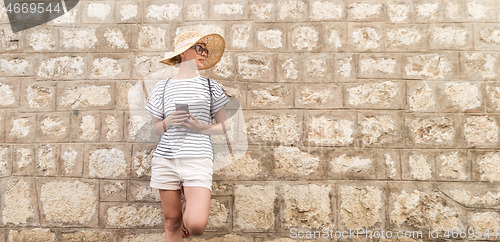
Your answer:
[401,149,437,181]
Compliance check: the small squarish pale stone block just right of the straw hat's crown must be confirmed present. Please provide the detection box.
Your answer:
[231,22,255,50]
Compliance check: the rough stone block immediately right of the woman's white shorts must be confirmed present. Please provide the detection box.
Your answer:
[213,144,266,180]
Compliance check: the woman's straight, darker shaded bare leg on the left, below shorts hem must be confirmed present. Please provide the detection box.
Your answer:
[160,190,182,242]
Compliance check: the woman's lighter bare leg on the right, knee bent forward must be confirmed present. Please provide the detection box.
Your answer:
[182,187,210,236]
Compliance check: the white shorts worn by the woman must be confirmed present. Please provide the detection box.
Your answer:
[150,156,213,191]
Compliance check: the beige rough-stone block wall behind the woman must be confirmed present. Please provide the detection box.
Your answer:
[0,0,500,242]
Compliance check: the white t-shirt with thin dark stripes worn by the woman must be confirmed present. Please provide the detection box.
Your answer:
[146,75,229,159]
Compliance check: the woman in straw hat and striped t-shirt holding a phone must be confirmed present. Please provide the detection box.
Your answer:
[146,31,229,242]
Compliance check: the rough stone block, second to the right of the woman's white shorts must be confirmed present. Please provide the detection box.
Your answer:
[273,145,324,180]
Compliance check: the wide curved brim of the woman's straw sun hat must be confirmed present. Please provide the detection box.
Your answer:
[160,34,226,70]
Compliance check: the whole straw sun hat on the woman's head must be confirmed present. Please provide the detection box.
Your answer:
[160,31,226,70]
